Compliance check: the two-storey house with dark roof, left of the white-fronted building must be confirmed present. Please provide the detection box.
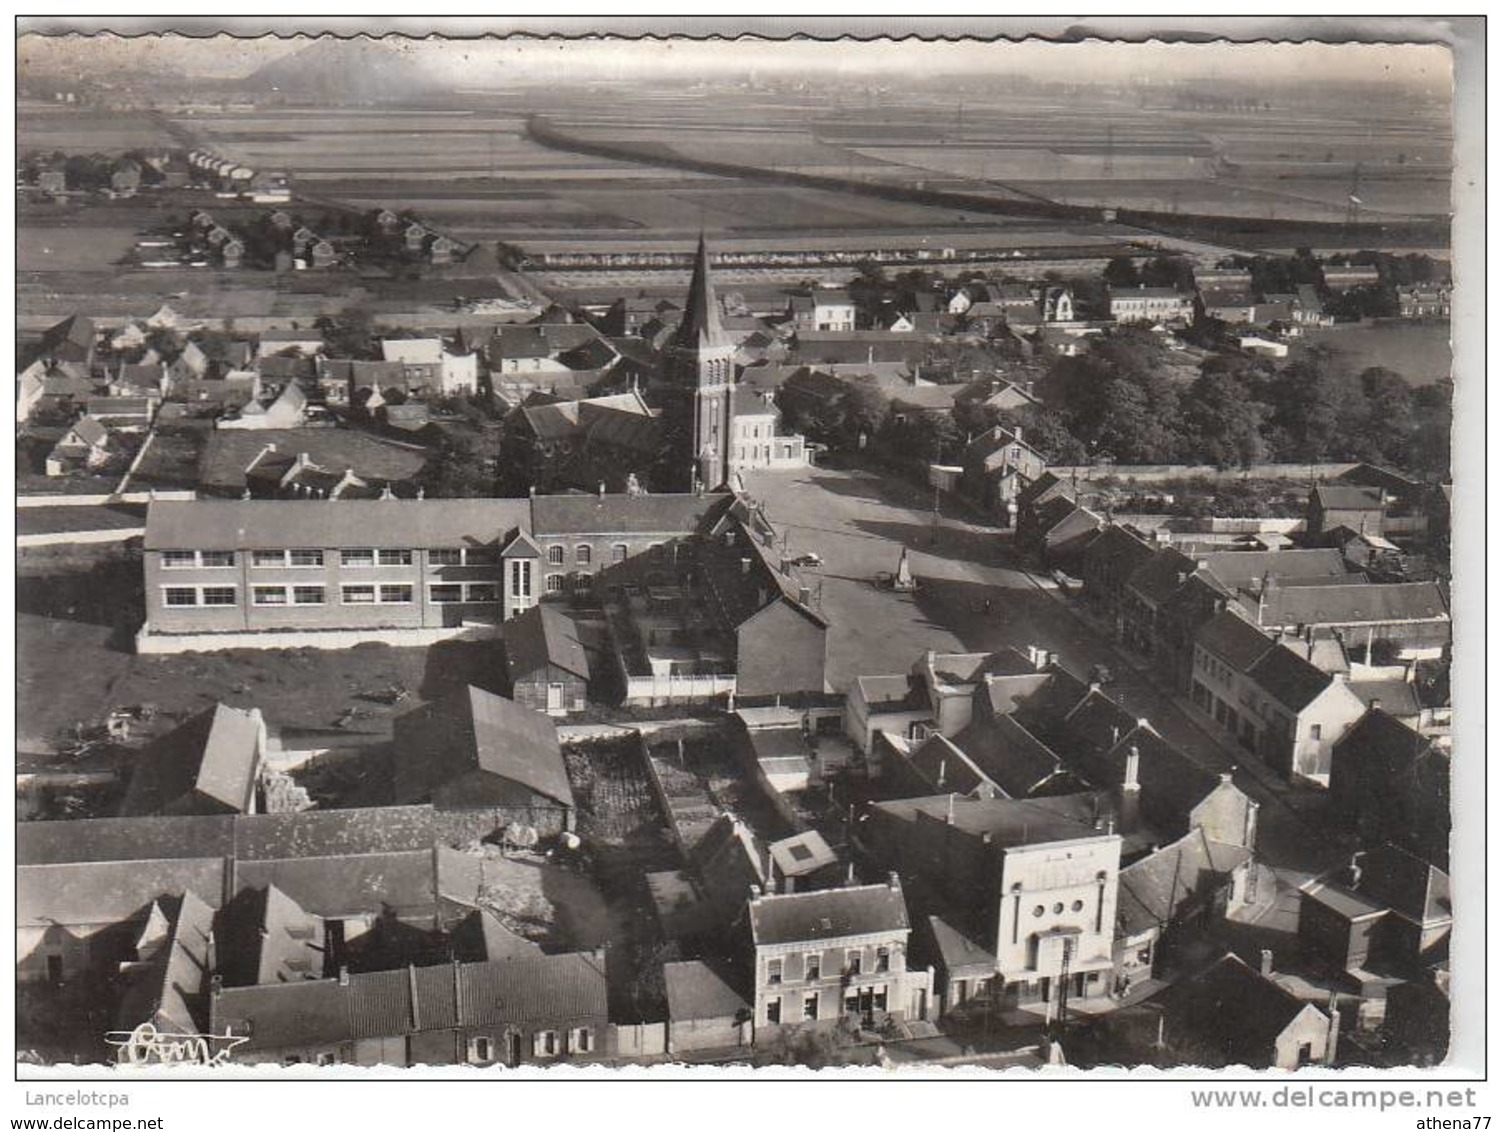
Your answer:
[746,875,933,1043]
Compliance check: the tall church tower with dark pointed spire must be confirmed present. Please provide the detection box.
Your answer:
[664,236,736,491]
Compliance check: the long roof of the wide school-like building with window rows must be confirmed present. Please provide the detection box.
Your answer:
[146,498,530,549]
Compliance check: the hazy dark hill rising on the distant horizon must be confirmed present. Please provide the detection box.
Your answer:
[239,36,439,105]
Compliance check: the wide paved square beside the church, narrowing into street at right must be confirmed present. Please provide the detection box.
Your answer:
[745,467,1344,884]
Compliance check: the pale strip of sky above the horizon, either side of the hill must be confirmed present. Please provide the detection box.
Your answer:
[18,36,1451,98]
